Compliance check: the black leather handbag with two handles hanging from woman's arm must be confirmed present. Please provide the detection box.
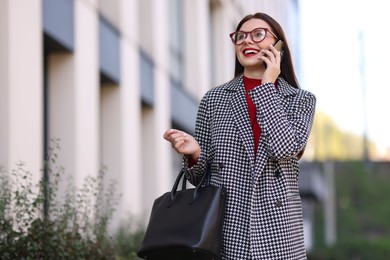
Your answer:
[137,164,226,260]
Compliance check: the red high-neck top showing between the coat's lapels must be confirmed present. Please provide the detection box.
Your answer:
[244,76,261,155]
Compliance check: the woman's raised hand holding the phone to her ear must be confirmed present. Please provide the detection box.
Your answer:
[258,45,282,84]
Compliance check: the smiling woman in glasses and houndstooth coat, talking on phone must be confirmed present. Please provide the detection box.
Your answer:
[164,13,316,260]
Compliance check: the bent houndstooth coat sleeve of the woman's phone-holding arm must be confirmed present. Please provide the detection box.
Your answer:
[250,83,316,160]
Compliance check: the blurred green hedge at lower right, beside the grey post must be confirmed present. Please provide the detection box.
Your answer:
[309,161,390,260]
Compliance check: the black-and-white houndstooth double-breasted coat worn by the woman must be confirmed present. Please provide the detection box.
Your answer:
[184,76,316,260]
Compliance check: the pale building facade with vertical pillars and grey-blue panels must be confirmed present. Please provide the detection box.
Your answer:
[0,0,298,231]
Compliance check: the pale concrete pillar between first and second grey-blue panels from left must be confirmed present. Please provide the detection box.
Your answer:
[74,1,100,186]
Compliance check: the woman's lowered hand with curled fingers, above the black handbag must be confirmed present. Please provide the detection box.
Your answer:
[164,129,200,161]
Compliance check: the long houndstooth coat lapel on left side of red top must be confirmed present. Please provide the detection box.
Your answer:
[228,76,255,169]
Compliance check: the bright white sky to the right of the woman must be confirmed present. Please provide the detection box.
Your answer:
[299,0,390,156]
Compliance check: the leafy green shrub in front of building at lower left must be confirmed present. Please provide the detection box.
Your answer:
[0,140,143,260]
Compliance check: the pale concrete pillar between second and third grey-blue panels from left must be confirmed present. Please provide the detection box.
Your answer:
[119,0,143,217]
